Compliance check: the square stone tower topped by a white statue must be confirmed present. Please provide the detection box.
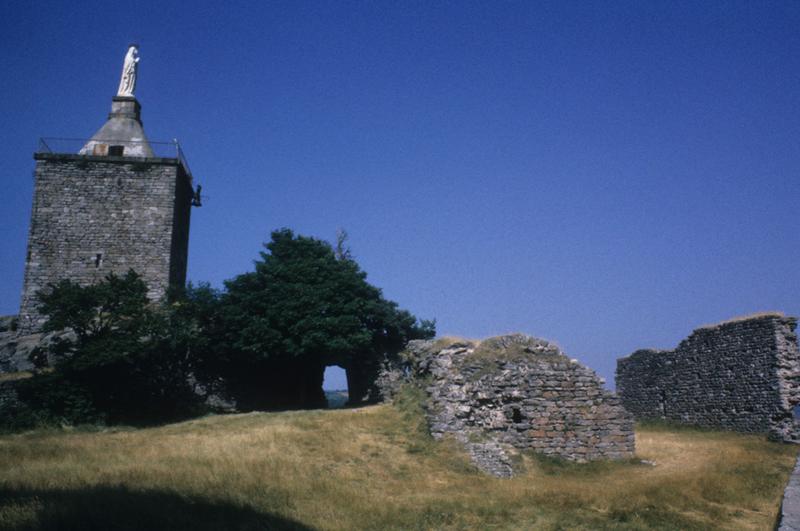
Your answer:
[19,45,199,333]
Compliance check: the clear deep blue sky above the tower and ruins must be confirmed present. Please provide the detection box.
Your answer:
[0,0,800,387]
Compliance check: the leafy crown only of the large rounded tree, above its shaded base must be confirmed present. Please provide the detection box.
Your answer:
[222,229,435,374]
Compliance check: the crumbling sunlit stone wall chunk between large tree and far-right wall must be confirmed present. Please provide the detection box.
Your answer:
[388,334,634,477]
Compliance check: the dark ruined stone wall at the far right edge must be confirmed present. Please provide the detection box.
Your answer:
[616,314,800,441]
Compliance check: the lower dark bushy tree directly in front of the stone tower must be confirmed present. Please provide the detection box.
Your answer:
[22,271,206,423]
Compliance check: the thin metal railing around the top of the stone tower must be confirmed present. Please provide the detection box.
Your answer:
[36,137,192,177]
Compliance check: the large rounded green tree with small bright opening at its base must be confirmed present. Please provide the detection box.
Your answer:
[221,229,435,407]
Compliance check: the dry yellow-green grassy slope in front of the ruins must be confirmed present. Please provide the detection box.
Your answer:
[0,392,797,530]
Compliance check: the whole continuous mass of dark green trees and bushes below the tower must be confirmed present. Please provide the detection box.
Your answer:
[0,229,435,424]
